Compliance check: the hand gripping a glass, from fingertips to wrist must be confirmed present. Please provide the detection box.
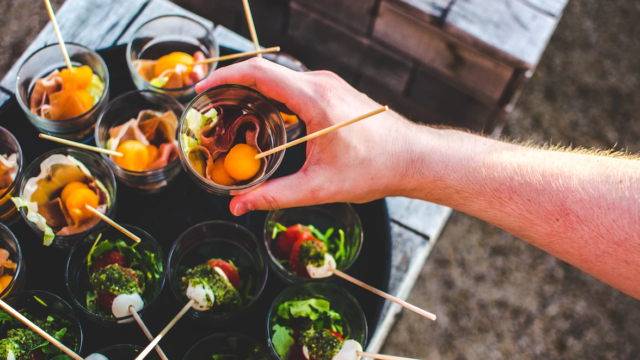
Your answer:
[196,58,417,216]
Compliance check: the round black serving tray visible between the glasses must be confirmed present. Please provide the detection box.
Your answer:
[0,46,391,360]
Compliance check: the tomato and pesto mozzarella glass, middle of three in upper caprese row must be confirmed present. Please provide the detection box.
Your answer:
[168,221,267,321]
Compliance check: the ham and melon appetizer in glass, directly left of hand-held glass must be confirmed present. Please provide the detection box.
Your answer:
[96,90,184,192]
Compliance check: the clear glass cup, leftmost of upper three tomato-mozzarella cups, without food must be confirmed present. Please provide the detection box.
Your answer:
[65,224,166,326]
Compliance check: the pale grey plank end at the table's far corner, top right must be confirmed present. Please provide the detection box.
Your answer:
[444,0,558,67]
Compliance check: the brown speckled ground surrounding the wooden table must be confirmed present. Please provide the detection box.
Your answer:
[0,0,640,359]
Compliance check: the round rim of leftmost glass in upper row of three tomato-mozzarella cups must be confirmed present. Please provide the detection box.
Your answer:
[64,224,167,324]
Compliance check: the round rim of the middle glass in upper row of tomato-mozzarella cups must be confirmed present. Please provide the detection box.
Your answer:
[166,220,269,315]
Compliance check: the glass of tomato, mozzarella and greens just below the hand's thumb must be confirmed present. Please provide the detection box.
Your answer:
[264,203,363,283]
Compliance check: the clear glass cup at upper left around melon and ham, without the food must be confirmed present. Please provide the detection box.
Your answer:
[16,43,109,142]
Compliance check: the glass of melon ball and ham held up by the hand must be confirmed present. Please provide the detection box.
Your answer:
[180,85,286,195]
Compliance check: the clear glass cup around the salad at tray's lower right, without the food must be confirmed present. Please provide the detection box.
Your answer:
[267,282,368,359]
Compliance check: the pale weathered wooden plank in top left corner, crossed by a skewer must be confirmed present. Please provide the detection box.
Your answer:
[0,0,146,94]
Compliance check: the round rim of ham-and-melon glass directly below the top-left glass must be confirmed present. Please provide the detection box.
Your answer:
[18,146,118,245]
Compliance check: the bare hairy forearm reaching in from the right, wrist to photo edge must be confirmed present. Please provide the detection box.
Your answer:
[404,128,640,298]
